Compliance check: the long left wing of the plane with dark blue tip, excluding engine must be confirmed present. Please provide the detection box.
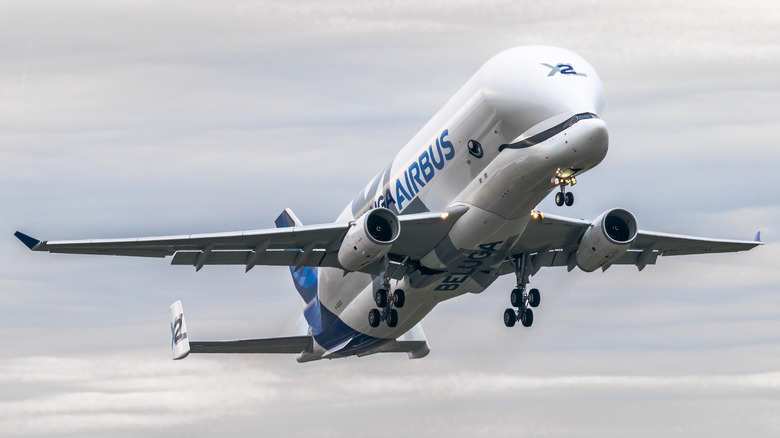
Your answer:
[15,205,468,274]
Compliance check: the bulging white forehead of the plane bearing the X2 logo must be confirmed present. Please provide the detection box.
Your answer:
[476,46,604,134]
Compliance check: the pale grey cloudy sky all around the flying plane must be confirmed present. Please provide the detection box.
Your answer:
[0,0,780,437]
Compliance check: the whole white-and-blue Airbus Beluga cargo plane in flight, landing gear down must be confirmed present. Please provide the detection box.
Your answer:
[16,47,761,362]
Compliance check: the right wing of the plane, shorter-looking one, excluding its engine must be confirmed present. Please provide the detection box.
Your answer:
[501,214,762,275]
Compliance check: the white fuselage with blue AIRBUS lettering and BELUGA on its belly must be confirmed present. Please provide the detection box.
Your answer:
[314,47,608,356]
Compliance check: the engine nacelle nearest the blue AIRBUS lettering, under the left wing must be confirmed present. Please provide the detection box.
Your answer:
[338,208,401,271]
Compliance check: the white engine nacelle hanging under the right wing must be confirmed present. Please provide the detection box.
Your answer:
[577,208,638,272]
